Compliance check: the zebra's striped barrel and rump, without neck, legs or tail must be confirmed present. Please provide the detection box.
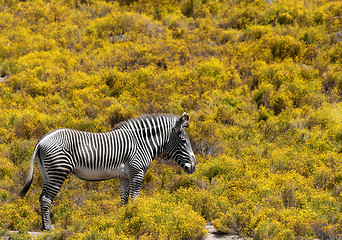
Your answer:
[40,129,136,181]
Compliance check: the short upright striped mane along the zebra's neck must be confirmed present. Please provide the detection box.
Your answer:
[112,114,178,131]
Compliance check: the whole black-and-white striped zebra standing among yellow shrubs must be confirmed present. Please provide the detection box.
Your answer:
[19,113,197,230]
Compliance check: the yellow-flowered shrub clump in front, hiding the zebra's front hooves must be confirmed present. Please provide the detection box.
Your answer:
[48,194,206,239]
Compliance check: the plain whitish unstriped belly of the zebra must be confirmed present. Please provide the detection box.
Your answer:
[72,164,128,181]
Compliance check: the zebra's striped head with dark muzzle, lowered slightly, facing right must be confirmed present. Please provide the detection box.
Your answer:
[165,113,197,174]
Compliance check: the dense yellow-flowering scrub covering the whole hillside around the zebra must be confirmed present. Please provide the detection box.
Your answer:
[0,0,342,239]
